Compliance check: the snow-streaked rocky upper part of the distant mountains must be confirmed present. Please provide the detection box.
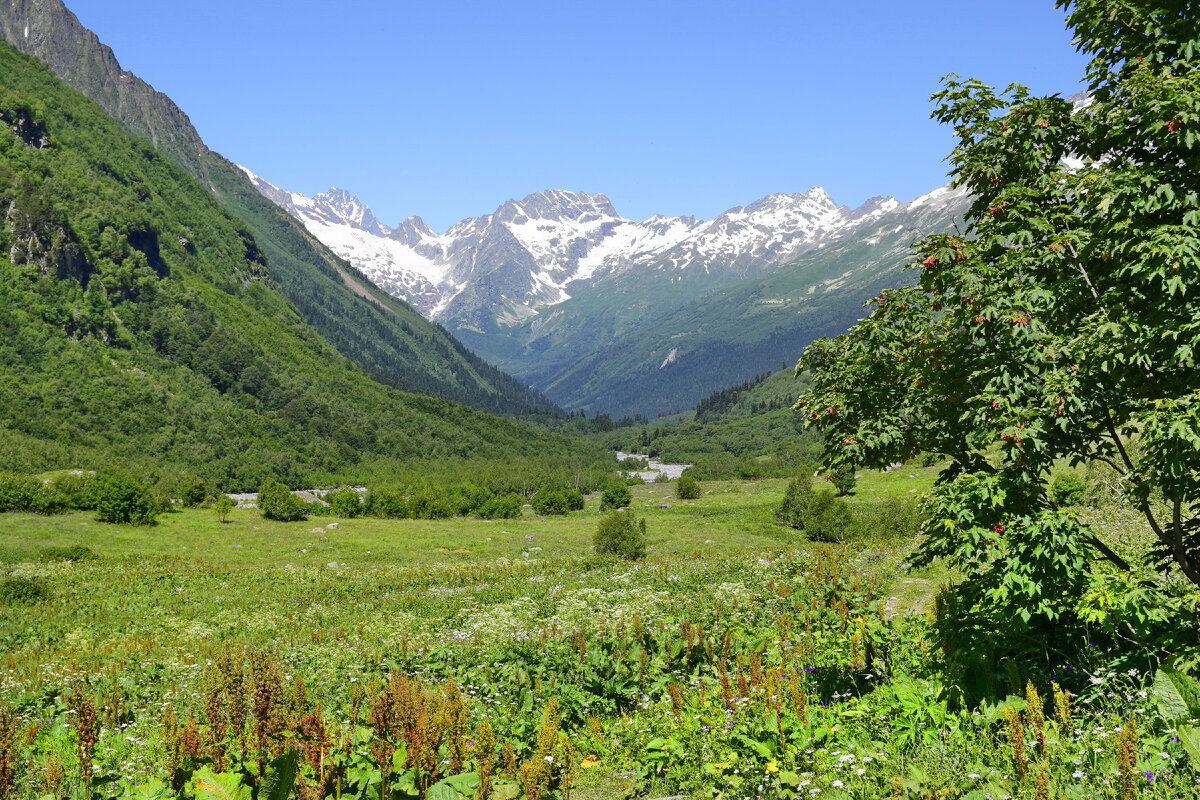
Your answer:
[234,168,900,327]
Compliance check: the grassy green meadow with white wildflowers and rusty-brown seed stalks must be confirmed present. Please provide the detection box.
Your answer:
[0,467,1177,800]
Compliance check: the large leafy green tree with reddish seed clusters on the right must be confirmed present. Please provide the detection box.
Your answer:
[797,0,1200,631]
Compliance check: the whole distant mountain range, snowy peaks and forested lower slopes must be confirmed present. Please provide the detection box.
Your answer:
[242,168,966,415]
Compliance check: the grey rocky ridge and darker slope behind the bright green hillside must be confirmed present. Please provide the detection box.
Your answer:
[0,0,551,414]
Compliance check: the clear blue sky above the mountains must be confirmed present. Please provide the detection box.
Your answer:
[66,0,1085,230]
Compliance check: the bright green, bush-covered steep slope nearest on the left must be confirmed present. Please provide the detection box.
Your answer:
[0,43,602,489]
